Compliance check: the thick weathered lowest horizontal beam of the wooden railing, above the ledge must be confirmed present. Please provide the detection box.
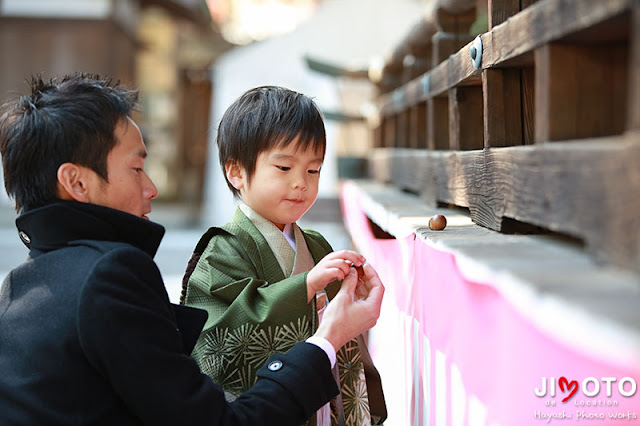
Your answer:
[372,140,640,272]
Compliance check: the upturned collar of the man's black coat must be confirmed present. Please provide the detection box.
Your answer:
[16,200,164,257]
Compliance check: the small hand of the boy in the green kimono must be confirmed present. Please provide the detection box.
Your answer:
[307,250,366,303]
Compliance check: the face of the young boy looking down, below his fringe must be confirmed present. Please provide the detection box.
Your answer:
[226,140,324,230]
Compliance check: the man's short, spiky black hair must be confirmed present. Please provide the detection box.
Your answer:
[0,74,138,212]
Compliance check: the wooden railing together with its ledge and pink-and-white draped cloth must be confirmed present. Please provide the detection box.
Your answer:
[341,0,640,426]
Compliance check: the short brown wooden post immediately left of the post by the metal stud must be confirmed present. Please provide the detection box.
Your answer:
[449,86,484,150]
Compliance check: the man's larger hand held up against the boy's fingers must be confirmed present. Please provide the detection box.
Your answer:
[315,263,384,351]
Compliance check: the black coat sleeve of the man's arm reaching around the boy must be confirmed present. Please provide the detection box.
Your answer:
[77,248,337,426]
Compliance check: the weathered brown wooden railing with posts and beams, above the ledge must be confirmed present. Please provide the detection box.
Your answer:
[372,0,640,271]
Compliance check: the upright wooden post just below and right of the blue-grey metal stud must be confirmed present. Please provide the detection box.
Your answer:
[482,68,522,147]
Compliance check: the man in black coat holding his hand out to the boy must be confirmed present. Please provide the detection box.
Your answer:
[0,74,384,426]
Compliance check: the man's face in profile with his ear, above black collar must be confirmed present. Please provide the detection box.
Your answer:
[89,118,158,219]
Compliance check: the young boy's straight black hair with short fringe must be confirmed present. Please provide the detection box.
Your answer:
[217,86,326,197]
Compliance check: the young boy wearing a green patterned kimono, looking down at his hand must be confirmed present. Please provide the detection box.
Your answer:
[182,86,380,426]
